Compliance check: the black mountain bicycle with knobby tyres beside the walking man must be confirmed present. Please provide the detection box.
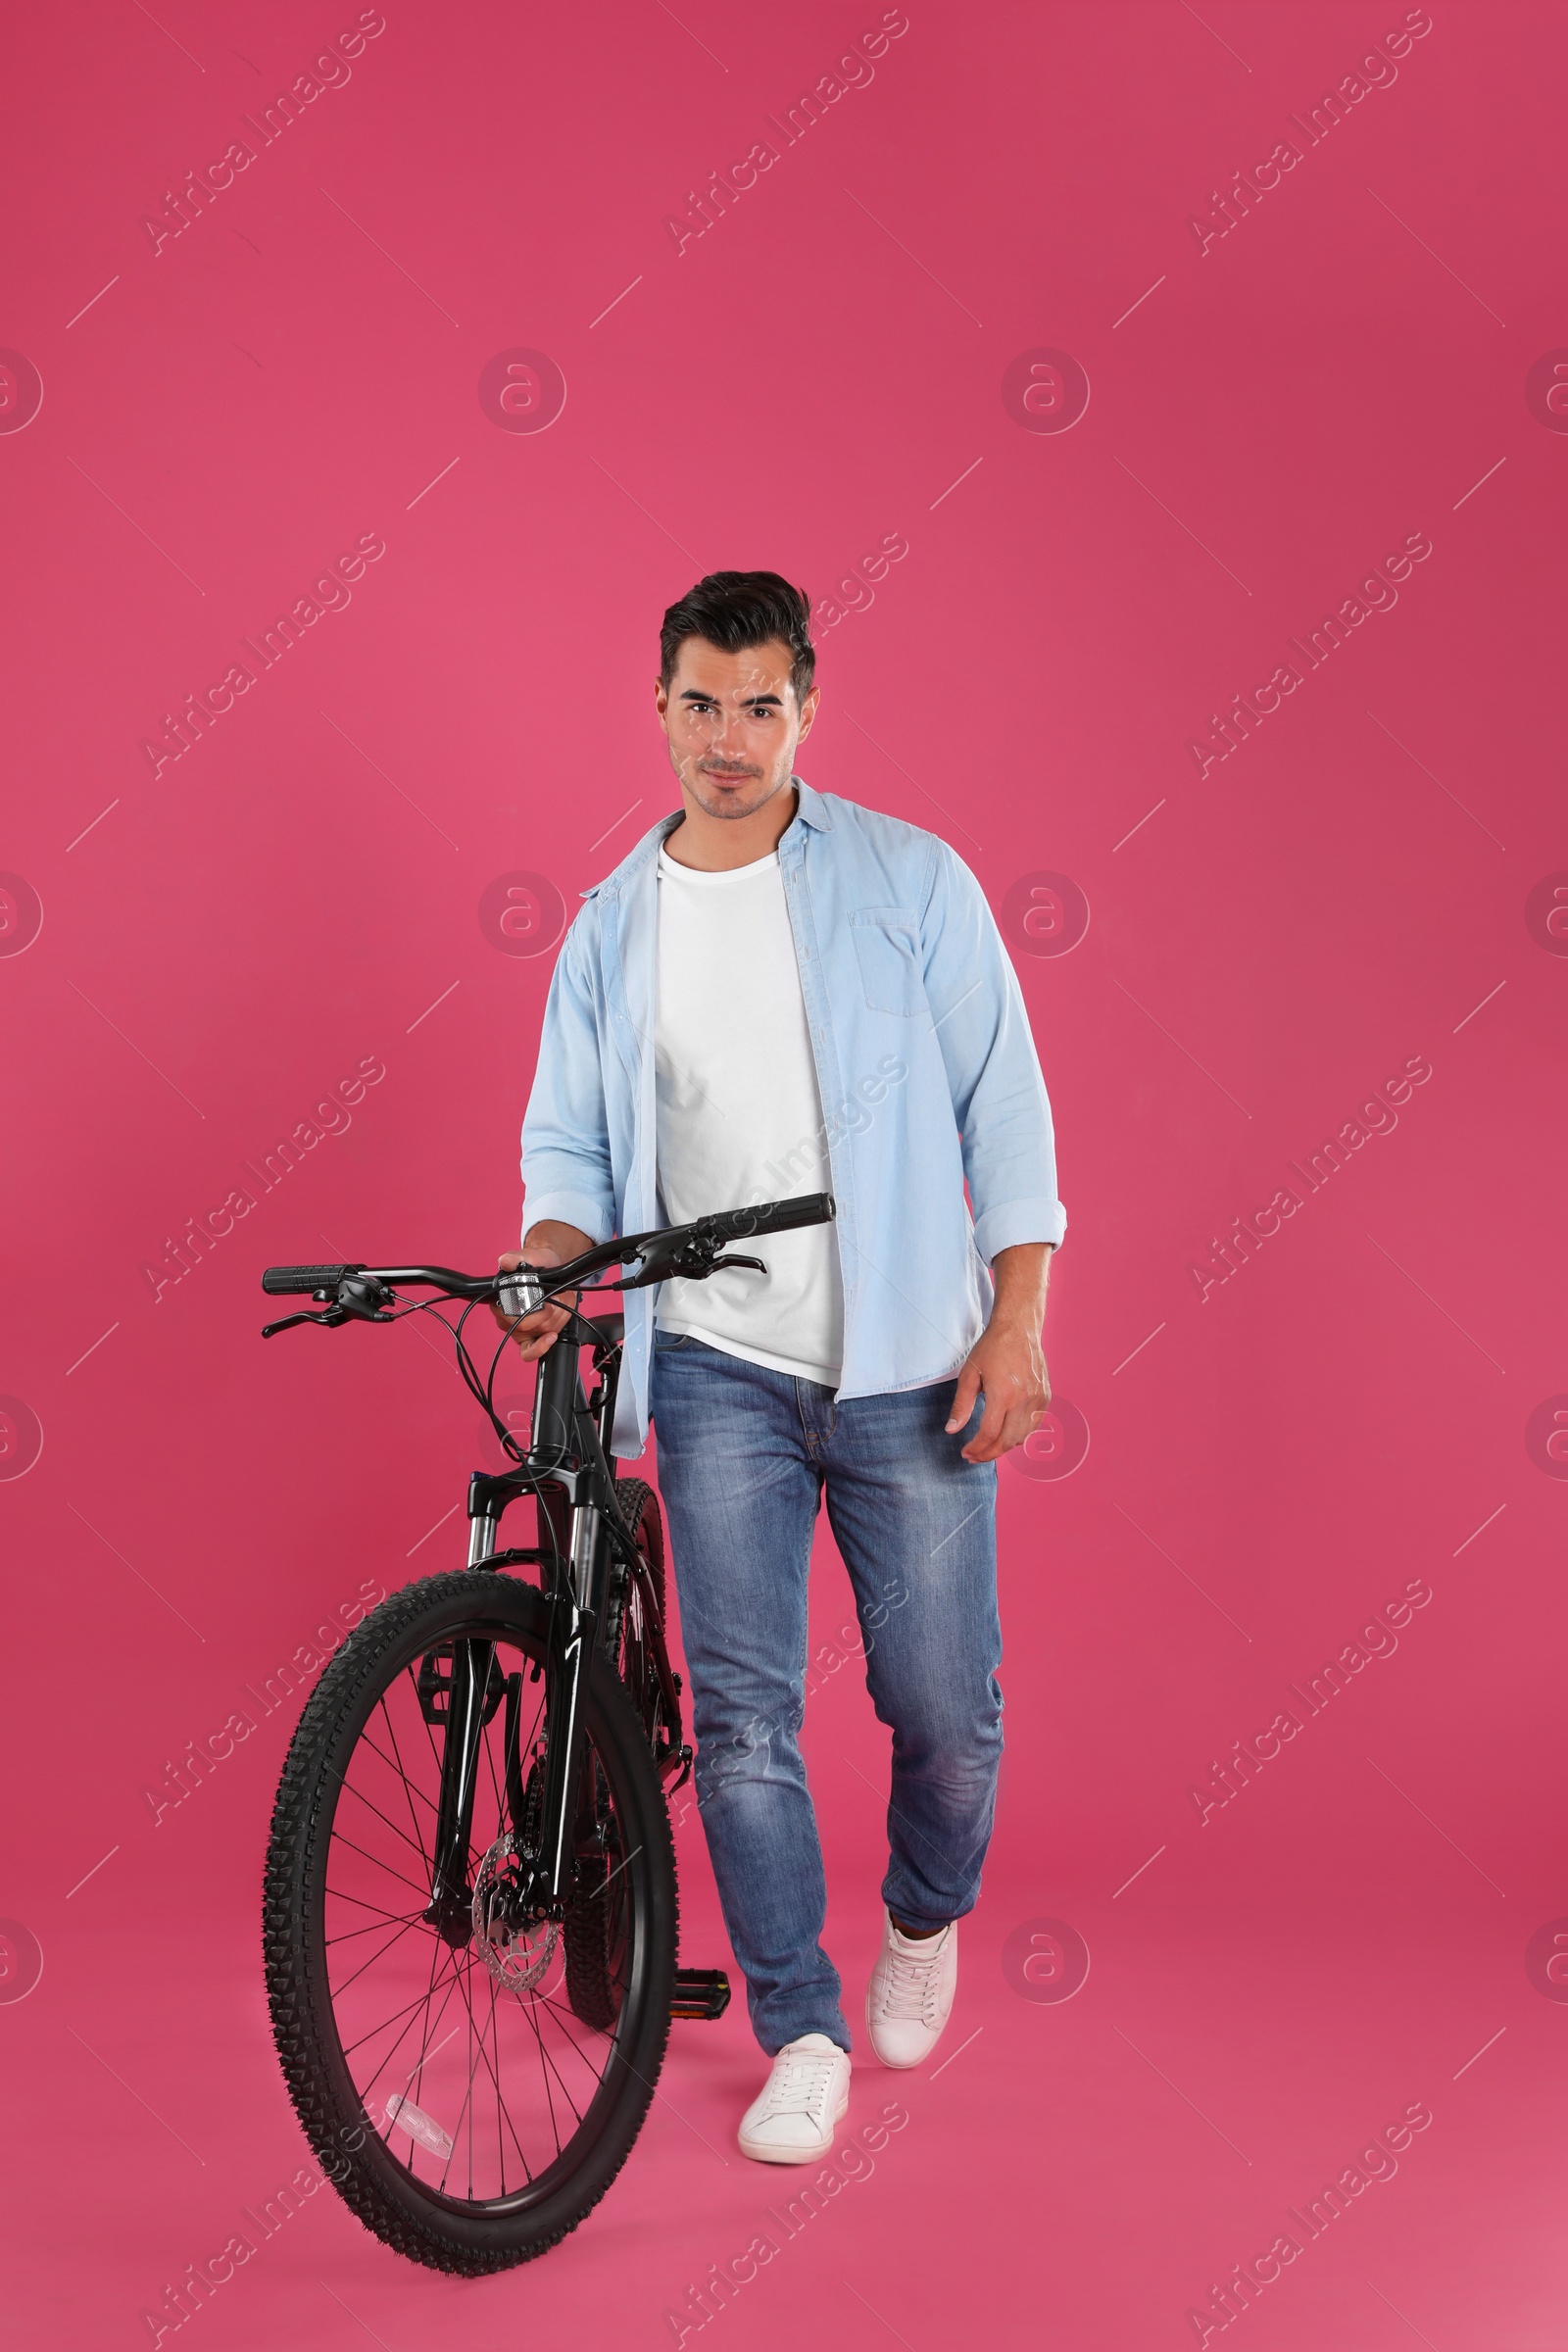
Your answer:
[261,1193,835,2275]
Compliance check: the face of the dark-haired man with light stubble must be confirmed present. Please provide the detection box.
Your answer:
[656,637,818,816]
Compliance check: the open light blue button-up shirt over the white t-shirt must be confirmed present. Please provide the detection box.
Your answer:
[522,776,1067,1456]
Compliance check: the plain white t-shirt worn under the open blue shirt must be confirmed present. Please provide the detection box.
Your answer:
[654,849,844,1388]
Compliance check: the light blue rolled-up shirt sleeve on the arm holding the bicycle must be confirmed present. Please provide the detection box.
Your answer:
[522,904,615,1242]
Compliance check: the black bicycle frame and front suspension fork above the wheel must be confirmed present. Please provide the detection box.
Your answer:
[428,1315,691,1934]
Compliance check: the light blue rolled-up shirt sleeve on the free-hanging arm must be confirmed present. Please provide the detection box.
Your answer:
[921,842,1067,1265]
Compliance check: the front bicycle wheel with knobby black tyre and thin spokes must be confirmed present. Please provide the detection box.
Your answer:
[264,1571,677,2272]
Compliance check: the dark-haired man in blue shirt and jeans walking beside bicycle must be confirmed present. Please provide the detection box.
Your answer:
[501,571,1065,2164]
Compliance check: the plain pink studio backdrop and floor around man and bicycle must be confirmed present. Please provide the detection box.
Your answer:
[0,0,1568,2352]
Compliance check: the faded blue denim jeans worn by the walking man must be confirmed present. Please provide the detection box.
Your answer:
[651,1331,1002,2056]
